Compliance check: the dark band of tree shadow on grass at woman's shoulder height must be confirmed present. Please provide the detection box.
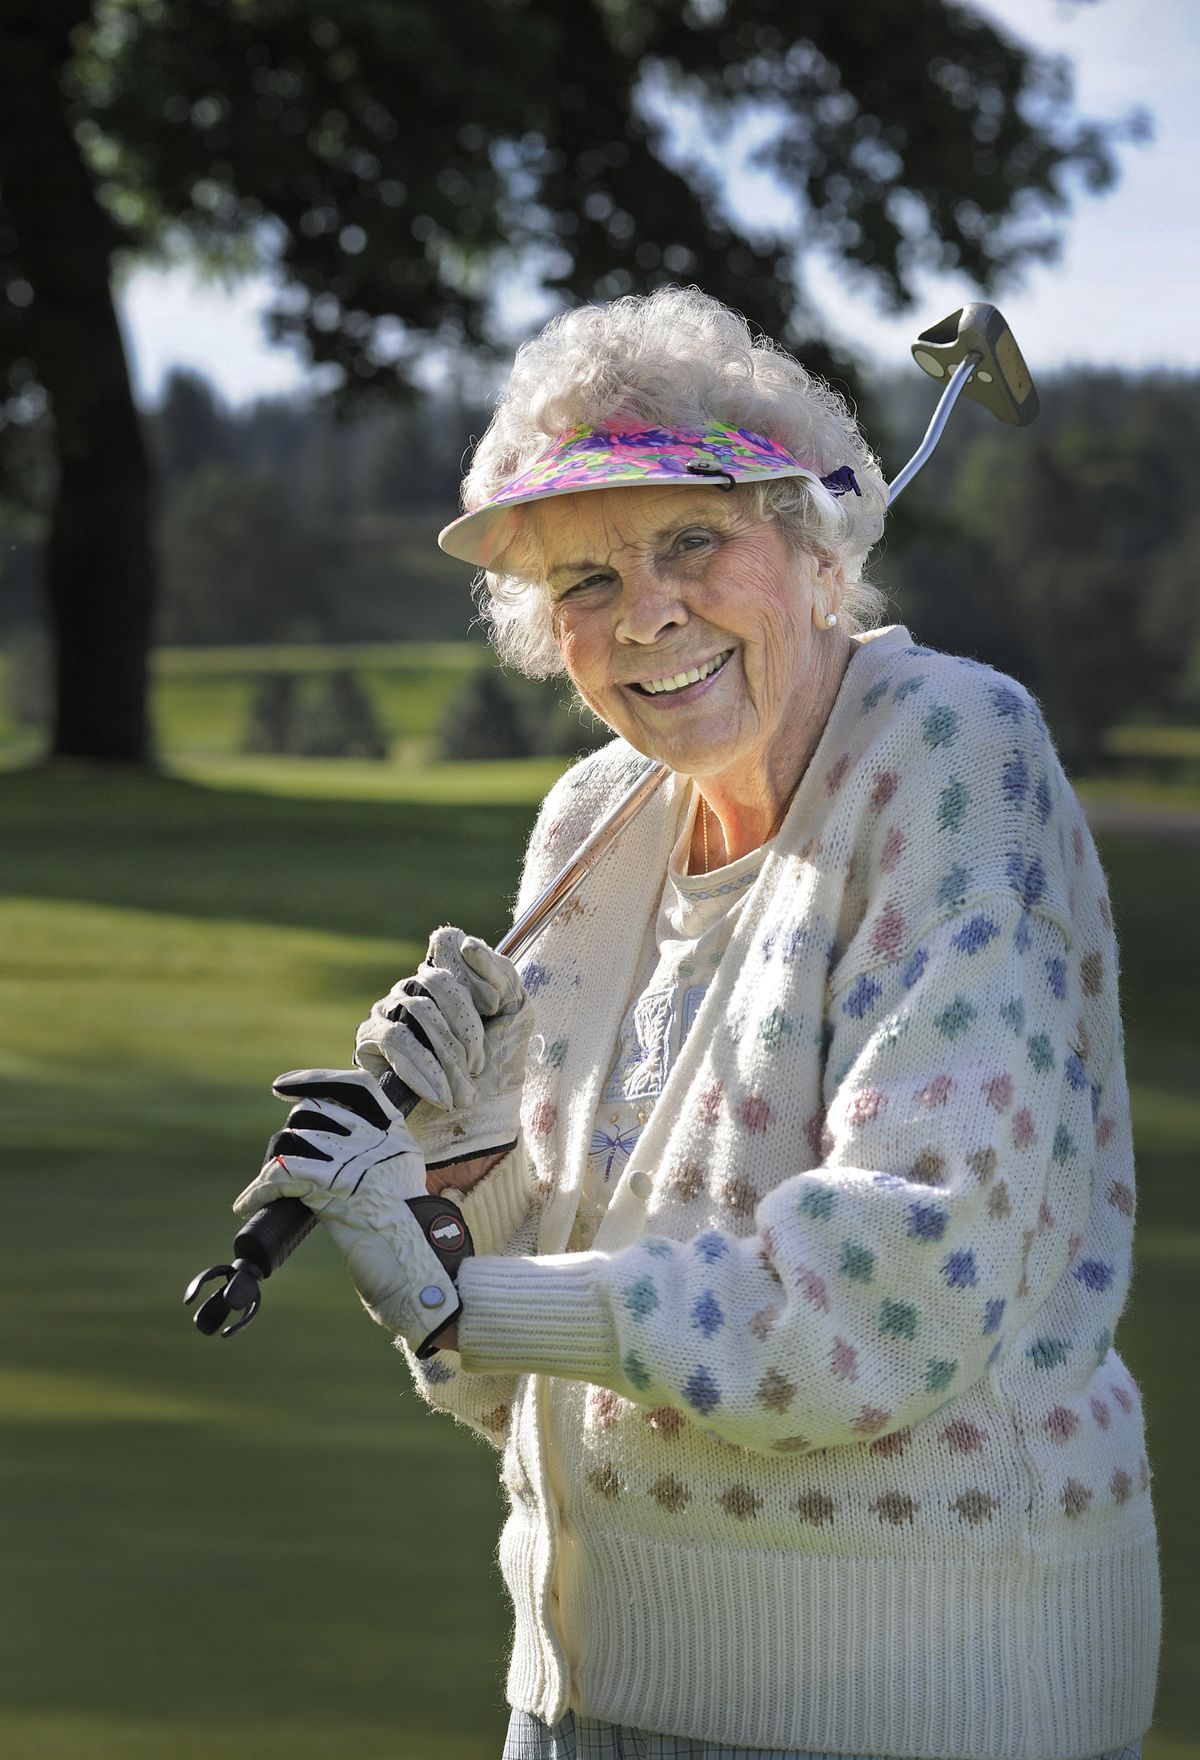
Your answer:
[0,771,537,942]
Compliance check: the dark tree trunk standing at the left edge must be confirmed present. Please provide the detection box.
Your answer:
[0,0,155,764]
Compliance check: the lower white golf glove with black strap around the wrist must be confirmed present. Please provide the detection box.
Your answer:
[234,1070,472,1357]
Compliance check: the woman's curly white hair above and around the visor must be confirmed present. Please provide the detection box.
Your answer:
[463,287,887,678]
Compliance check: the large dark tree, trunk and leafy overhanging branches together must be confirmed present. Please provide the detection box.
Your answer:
[0,0,1133,760]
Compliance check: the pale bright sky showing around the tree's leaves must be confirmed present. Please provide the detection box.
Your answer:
[120,0,1200,405]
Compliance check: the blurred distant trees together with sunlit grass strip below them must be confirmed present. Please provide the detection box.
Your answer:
[0,368,1200,780]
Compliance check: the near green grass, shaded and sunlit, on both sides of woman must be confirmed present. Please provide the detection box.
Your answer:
[0,757,1200,1760]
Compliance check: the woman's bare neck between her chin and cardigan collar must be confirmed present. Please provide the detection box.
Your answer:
[688,634,855,873]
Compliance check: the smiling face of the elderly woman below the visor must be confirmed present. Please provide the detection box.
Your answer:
[530,486,843,796]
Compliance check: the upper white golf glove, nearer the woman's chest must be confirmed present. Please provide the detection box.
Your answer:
[354,928,533,1167]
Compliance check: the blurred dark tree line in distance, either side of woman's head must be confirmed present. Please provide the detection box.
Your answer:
[0,371,1200,769]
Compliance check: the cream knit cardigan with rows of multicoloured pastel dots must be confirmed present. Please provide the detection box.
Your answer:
[405,627,1160,1760]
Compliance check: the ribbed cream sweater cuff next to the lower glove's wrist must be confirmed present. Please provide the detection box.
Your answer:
[457,1253,616,1382]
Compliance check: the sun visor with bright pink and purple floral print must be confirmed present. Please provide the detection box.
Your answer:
[438,424,862,568]
